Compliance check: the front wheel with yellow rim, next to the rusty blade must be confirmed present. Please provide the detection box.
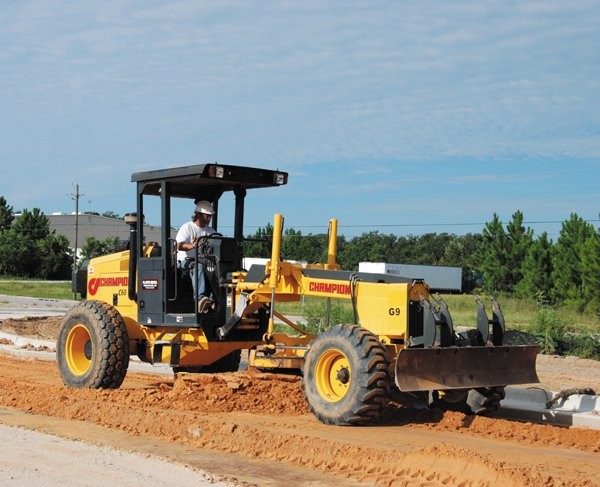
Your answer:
[302,325,390,425]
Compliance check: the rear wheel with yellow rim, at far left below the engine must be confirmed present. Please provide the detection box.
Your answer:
[56,301,129,389]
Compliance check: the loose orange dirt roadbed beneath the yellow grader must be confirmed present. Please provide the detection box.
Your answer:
[0,314,600,486]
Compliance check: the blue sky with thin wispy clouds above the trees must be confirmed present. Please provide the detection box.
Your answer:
[0,0,600,238]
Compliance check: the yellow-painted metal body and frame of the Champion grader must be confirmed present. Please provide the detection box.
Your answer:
[83,214,422,372]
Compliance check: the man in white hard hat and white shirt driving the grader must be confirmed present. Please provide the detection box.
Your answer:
[175,200,215,313]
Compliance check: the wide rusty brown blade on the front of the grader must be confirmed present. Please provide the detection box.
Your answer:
[395,345,540,392]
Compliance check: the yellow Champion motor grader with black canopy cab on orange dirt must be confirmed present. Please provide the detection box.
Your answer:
[57,164,539,425]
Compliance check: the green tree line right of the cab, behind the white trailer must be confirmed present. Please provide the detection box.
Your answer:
[245,211,600,313]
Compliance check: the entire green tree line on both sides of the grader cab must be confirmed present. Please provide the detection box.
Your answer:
[0,196,600,313]
